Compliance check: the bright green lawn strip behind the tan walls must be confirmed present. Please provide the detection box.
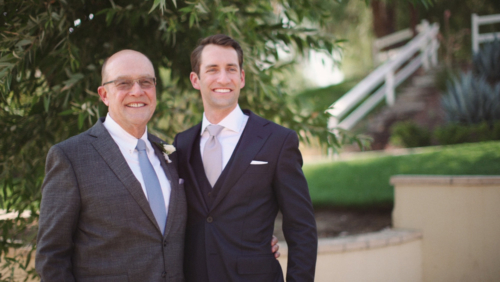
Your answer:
[304,141,500,208]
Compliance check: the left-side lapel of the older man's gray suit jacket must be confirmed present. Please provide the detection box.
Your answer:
[89,119,159,229]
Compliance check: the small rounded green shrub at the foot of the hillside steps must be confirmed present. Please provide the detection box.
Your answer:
[390,121,431,148]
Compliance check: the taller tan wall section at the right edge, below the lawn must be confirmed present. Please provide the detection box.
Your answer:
[391,176,500,282]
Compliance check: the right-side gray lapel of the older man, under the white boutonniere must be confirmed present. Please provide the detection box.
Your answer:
[148,133,179,237]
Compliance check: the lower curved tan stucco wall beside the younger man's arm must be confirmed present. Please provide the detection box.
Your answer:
[279,230,422,282]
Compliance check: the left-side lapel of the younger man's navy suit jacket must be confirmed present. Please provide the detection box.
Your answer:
[177,123,208,210]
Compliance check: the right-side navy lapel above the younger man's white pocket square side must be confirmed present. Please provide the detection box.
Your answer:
[211,112,271,210]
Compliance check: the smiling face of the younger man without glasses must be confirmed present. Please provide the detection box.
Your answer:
[190,44,245,122]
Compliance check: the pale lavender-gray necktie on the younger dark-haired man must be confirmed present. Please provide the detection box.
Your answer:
[203,124,224,187]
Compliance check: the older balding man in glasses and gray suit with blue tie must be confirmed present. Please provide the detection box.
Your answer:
[36,50,186,282]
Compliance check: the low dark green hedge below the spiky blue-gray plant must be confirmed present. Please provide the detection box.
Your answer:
[434,121,500,145]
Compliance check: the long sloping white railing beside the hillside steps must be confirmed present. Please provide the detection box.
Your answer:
[326,21,439,132]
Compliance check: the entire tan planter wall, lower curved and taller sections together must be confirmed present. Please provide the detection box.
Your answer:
[279,175,500,282]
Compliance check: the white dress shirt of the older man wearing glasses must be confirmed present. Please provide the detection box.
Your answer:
[103,113,171,216]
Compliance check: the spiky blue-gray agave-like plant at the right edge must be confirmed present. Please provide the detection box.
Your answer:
[441,72,500,124]
